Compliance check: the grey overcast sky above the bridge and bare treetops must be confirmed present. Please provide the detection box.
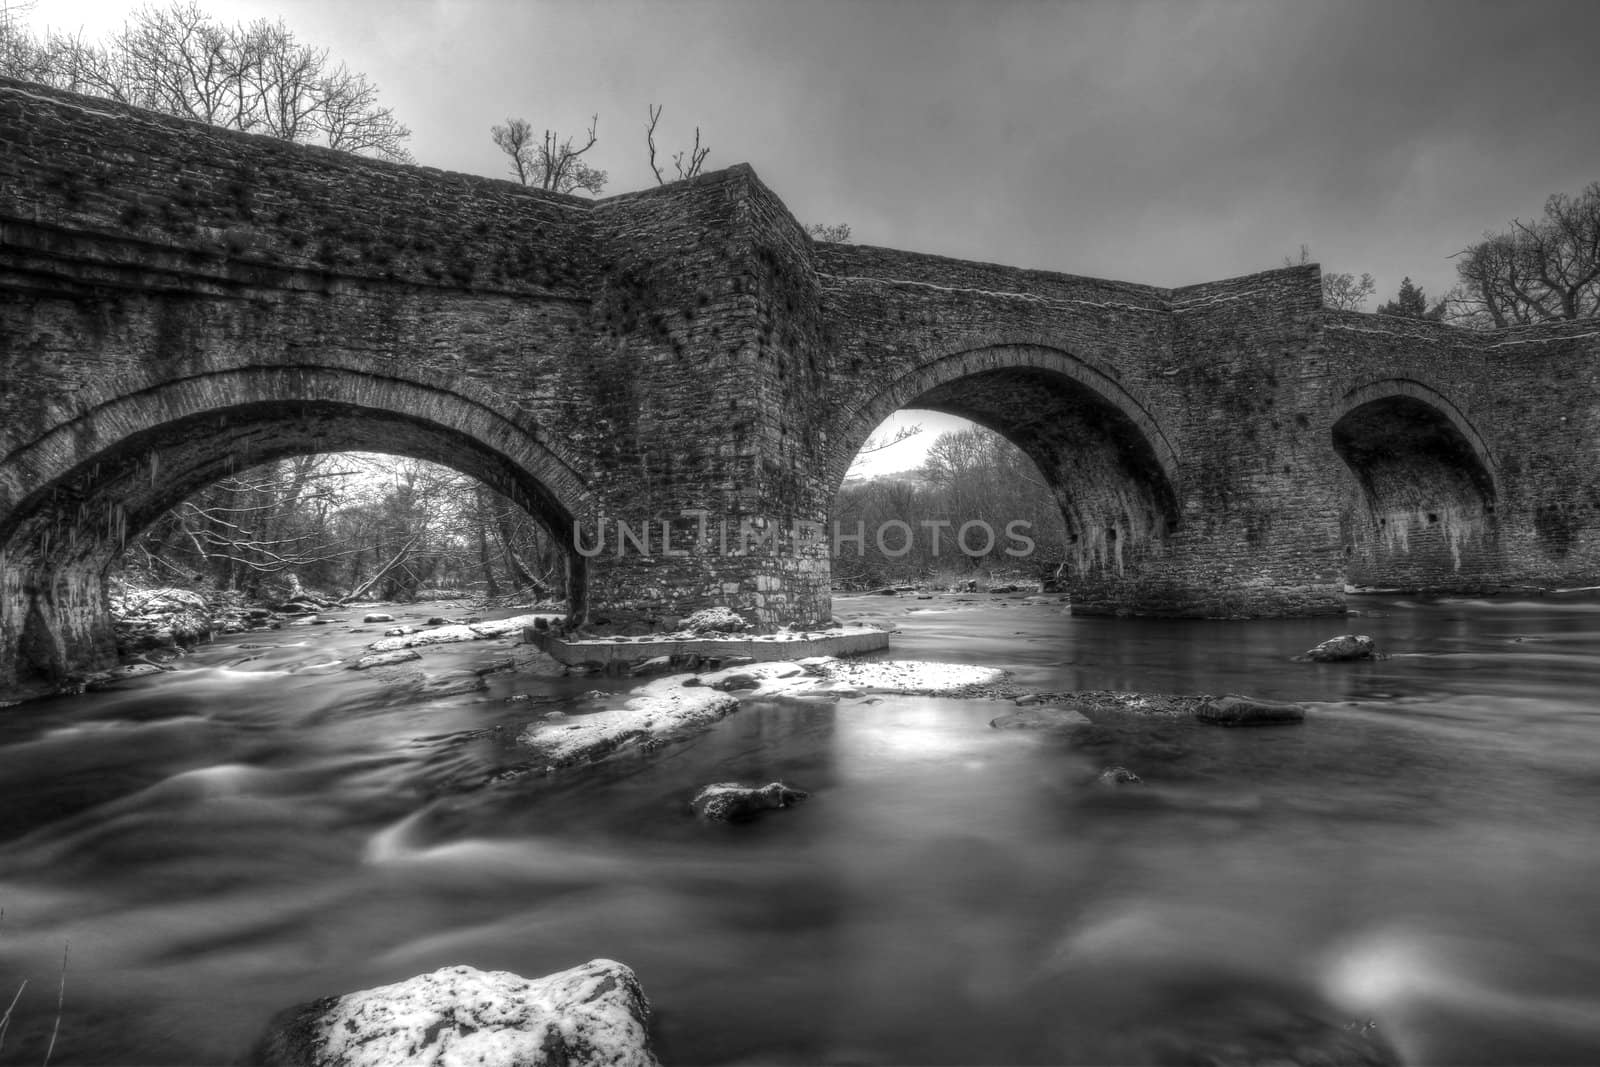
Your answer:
[13,0,1600,476]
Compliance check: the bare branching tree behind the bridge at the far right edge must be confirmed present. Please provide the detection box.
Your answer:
[1450,181,1600,326]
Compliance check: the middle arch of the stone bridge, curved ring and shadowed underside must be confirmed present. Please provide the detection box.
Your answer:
[830,344,1181,571]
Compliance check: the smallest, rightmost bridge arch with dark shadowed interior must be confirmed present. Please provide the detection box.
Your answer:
[1330,378,1499,589]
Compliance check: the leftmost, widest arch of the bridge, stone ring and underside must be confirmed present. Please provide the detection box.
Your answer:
[0,366,589,677]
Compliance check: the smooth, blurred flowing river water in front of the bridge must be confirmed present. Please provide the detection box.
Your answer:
[0,597,1600,1064]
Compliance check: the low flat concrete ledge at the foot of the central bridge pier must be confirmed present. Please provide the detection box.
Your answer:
[523,627,890,667]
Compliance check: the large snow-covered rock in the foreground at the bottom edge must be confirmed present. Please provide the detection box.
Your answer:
[253,960,658,1067]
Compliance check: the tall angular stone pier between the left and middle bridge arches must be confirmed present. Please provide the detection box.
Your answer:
[574,166,829,625]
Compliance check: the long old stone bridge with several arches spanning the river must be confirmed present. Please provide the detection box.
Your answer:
[9,80,1600,686]
